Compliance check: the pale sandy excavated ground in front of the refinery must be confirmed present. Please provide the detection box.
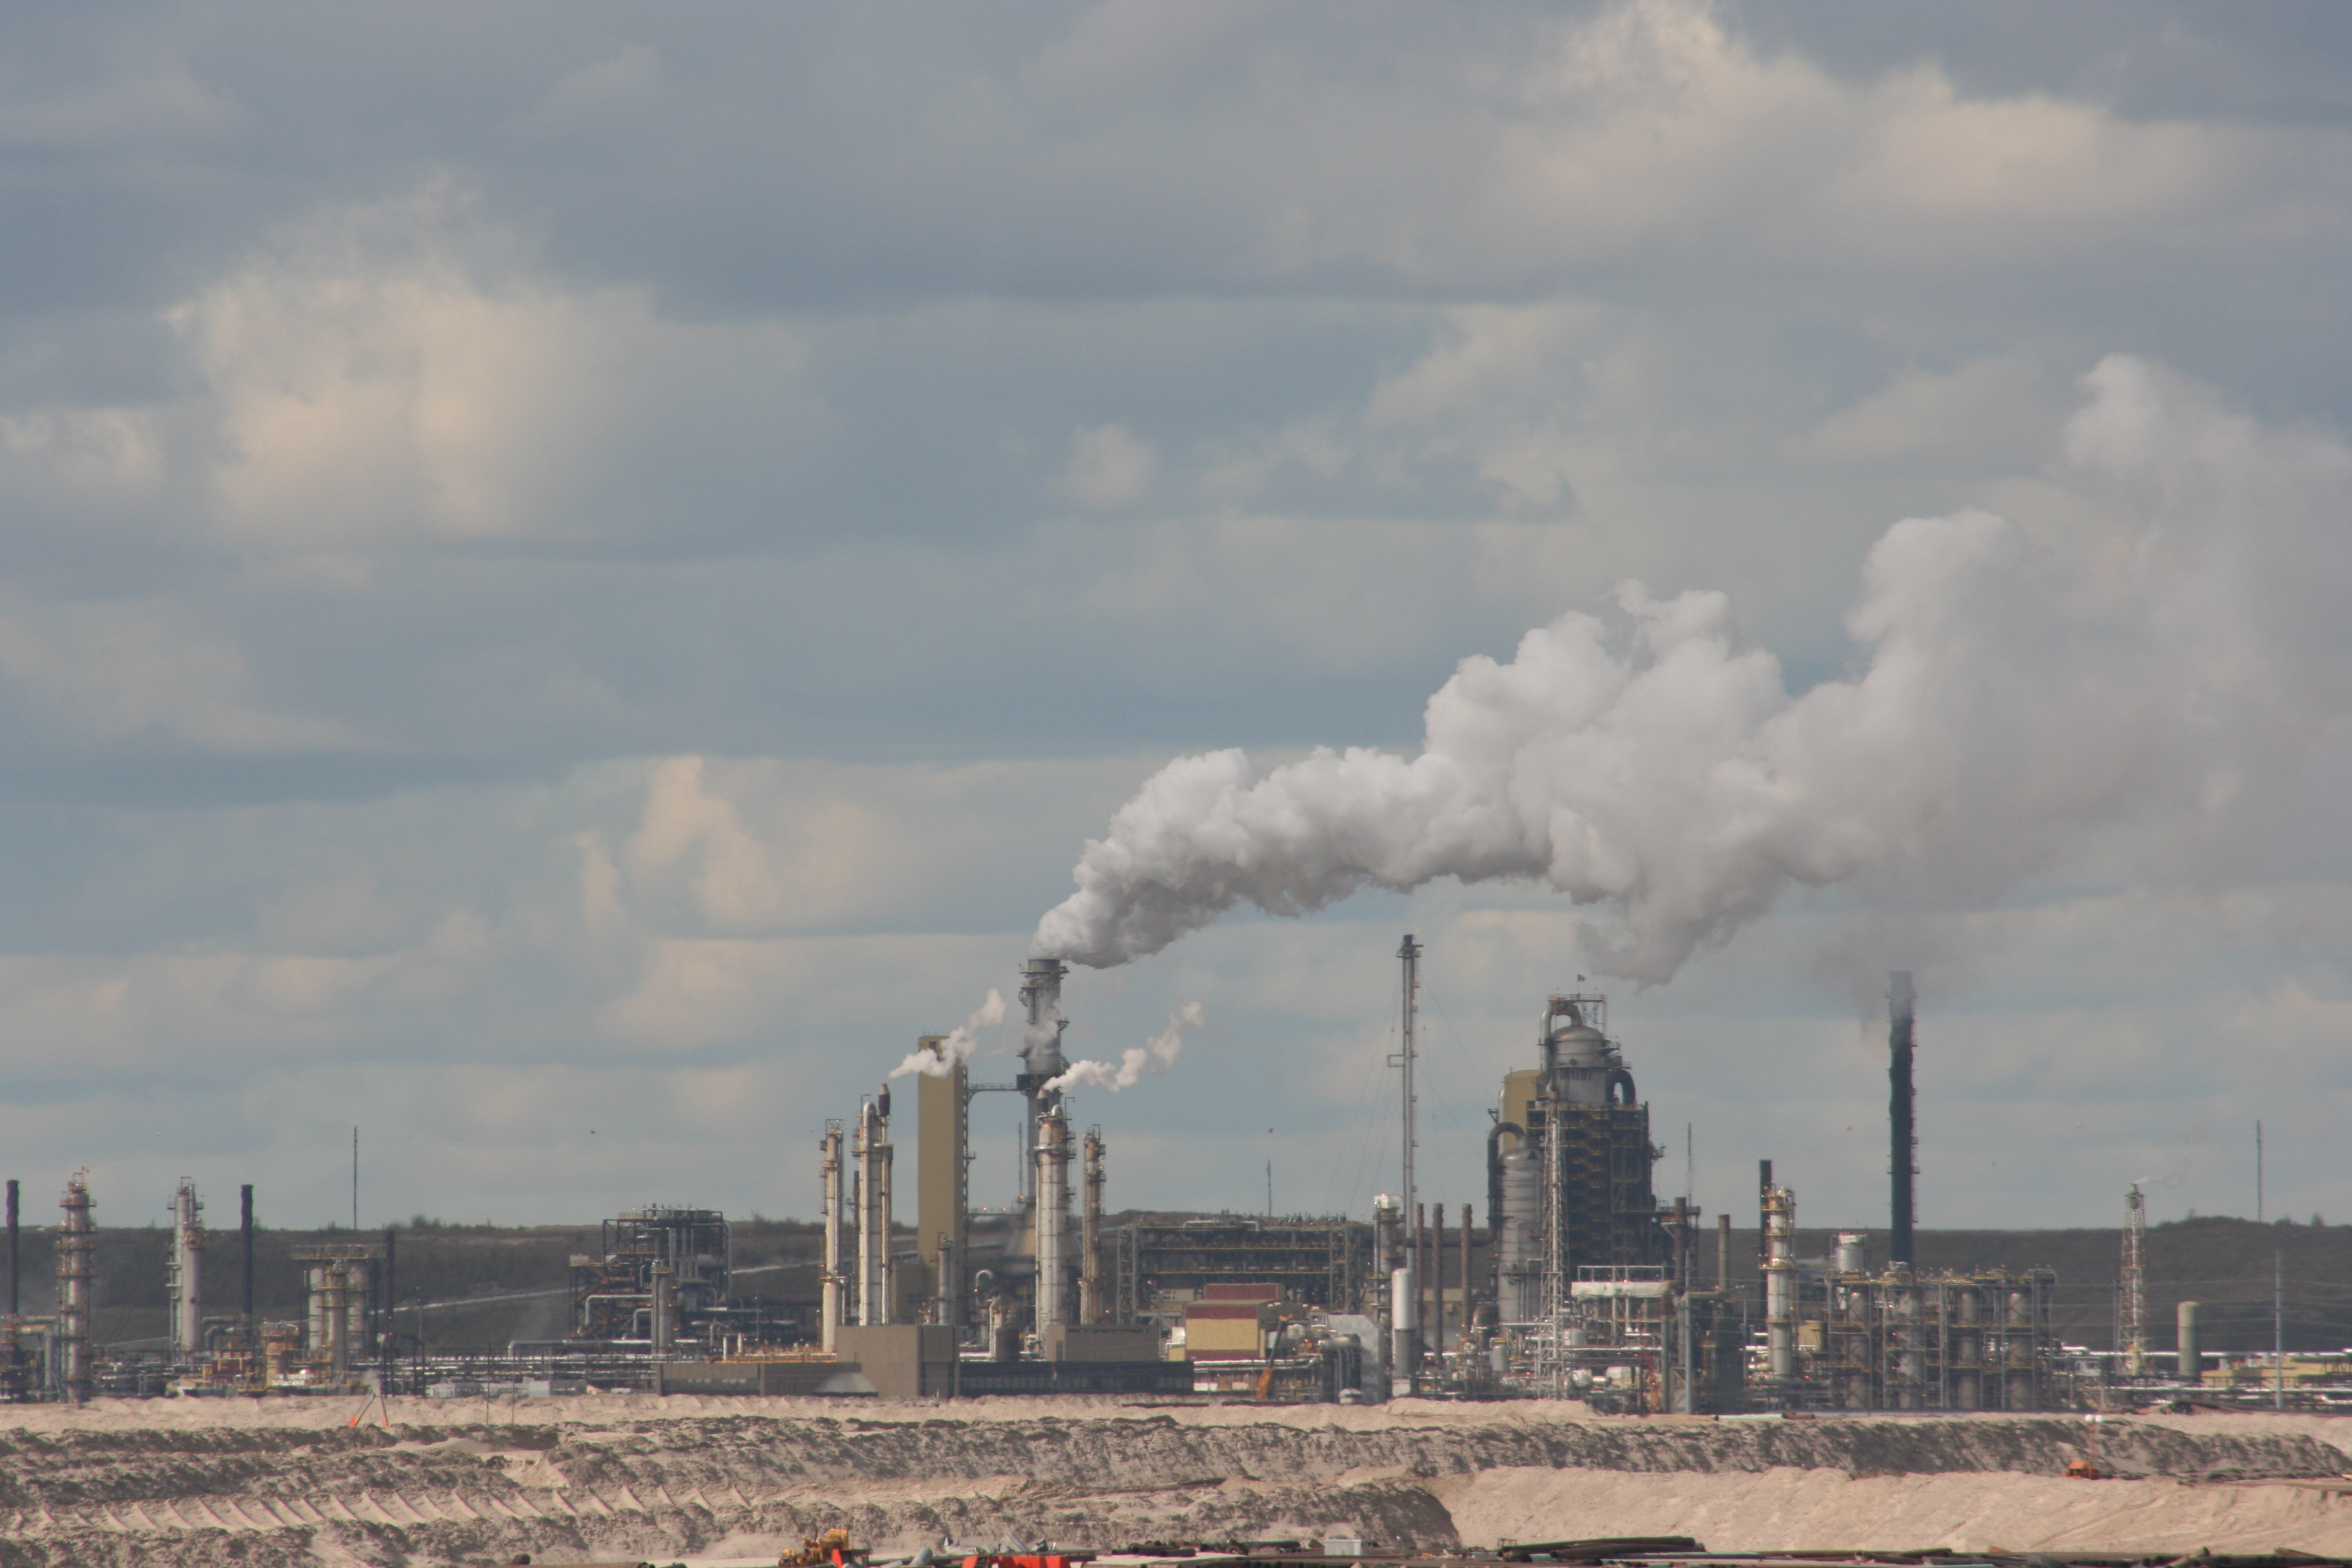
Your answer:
[0,1396,2352,1568]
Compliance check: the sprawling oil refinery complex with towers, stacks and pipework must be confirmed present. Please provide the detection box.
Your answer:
[0,936,2328,1415]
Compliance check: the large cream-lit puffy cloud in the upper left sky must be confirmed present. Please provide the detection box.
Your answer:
[149,178,826,552]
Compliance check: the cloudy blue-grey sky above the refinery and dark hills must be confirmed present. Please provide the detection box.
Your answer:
[0,0,2352,1227]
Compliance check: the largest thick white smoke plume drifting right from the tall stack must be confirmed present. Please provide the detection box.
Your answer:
[1033,358,2352,982]
